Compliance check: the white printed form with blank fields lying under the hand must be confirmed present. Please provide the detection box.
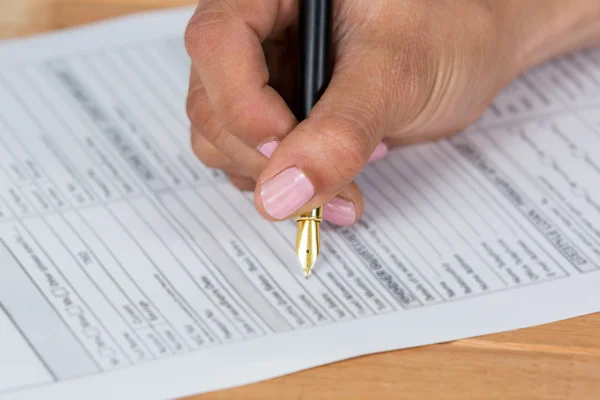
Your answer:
[0,8,600,400]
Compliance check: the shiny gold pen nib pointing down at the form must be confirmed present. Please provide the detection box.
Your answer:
[296,207,323,279]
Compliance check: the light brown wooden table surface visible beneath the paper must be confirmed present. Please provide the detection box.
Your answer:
[0,0,600,400]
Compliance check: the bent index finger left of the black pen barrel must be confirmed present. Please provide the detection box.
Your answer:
[186,0,296,147]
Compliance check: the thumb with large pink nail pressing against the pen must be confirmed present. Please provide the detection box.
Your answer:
[255,53,389,220]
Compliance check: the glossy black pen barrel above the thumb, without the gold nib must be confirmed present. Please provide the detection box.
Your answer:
[296,0,333,121]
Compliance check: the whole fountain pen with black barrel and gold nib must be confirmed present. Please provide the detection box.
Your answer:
[296,0,333,278]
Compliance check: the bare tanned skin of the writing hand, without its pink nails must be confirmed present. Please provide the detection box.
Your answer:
[186,0,600,225]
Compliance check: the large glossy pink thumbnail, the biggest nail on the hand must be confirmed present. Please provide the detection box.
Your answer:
[260,167,315,220]
